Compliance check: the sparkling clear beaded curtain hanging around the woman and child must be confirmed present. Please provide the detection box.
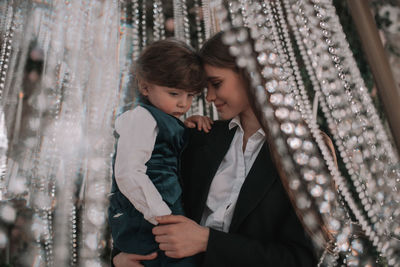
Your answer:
[0,0,400,266]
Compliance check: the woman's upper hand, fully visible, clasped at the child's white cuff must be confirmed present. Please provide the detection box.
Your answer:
[153,215,210,258]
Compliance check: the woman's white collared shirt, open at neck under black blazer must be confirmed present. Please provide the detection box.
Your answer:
[200,117,265,232]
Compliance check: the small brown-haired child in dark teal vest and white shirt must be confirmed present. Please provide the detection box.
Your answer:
[109,39,211,266]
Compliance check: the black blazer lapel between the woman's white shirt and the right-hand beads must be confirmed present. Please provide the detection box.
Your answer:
[229,144,278,232]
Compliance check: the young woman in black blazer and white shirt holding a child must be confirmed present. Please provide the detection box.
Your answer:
[113,30,316,267]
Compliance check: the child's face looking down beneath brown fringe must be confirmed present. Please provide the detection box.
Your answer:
[141,84,195,118]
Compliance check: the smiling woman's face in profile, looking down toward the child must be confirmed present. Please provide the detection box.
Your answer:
[204,64,251,120]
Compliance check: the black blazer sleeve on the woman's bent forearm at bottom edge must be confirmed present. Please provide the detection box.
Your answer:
[203,207,317,267]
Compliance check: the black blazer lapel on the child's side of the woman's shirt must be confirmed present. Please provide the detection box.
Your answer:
[193,121,236,222]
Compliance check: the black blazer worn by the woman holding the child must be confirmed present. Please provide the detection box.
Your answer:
[181,121,316,267]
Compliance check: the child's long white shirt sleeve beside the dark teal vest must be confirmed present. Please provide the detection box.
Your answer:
[114,106,171,225]
